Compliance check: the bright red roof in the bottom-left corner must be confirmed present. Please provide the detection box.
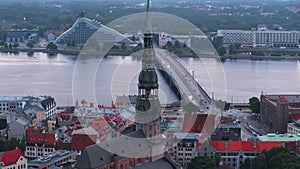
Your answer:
[0,149,24,166]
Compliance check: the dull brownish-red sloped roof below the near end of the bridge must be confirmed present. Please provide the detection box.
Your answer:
[182,113,208,133]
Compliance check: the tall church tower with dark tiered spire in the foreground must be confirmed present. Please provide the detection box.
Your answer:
[135,0,161,140]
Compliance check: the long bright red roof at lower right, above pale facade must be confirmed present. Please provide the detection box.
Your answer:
[211,141,282,152]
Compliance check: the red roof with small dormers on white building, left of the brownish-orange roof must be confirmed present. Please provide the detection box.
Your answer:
[26,126,55,146]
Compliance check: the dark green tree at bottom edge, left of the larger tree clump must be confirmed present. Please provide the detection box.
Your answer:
[187,156,217,169]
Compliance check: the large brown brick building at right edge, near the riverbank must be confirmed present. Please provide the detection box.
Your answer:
[260,95,300,134]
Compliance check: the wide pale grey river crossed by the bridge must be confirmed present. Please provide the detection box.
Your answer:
[0,53,300,105]
